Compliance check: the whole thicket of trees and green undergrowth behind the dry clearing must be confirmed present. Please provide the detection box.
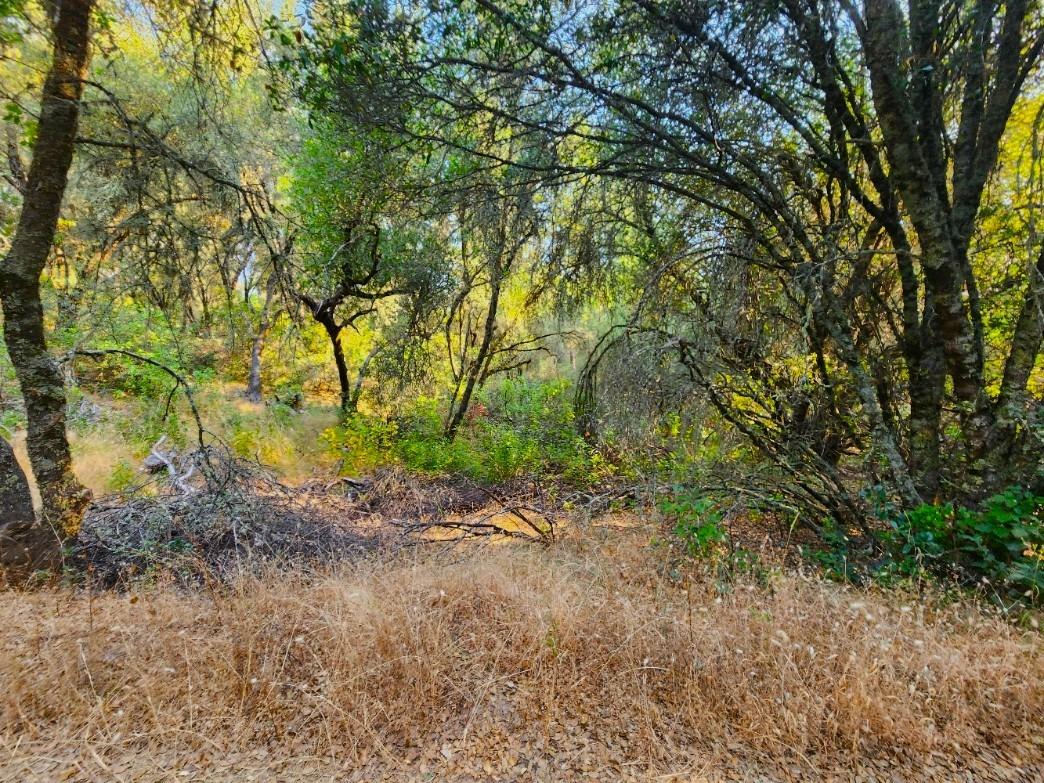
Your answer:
[0,0,1044,604]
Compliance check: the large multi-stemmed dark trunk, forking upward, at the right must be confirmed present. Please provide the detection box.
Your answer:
[863,0,1044,469]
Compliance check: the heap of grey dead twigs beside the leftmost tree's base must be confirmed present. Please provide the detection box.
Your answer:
[72,448,383,586]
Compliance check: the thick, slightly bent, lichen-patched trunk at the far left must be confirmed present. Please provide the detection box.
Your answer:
[0,0,94,550]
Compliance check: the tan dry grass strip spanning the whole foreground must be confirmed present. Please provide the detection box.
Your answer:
[0,532,1044,780]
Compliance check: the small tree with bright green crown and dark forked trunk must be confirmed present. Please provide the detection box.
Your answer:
[287,124,448,413]
